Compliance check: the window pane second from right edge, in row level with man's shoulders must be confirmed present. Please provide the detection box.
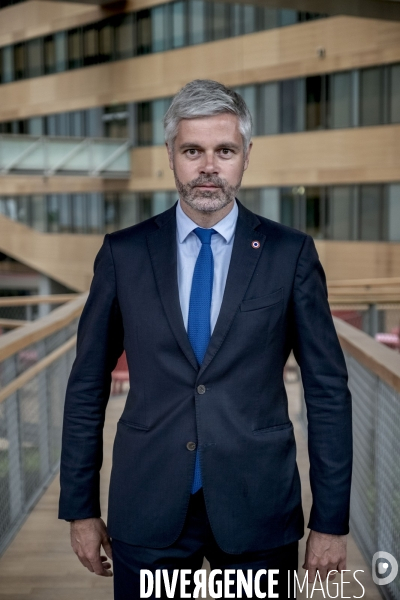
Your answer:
[359,185,383,241]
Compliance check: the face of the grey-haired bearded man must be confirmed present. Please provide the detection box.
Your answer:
[167,113,251,213]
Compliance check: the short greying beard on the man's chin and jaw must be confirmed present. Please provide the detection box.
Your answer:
[175,173,241,213]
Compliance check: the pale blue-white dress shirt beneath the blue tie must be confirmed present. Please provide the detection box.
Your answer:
[176,200,239,333]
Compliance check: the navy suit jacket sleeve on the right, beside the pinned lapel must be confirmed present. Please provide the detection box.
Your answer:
[293,236,353,535]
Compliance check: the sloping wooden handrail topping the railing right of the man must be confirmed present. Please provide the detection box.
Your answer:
[333,317,400,392]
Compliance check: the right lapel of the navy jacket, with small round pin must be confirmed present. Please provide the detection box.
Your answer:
[199,202,265,376]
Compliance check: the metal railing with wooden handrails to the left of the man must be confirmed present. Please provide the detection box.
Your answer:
[0,296,86,553]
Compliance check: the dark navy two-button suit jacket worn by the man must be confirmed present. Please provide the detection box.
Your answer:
[59,203,352,553]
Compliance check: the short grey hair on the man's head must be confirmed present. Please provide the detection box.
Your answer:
[164,79,252,152]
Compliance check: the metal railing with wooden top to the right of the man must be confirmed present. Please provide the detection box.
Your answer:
[301,318,400,600]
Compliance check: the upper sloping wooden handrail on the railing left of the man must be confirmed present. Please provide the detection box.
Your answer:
[0,294,87,361]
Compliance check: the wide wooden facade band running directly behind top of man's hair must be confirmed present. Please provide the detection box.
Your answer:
[0,15,400,121]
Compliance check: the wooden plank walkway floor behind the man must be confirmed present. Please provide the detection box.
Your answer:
[0,383,381,600]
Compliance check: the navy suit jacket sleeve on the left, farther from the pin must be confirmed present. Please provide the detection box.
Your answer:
[59,236,123,520]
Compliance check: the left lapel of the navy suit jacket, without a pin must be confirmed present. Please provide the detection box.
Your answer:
[147,205,199,371]
